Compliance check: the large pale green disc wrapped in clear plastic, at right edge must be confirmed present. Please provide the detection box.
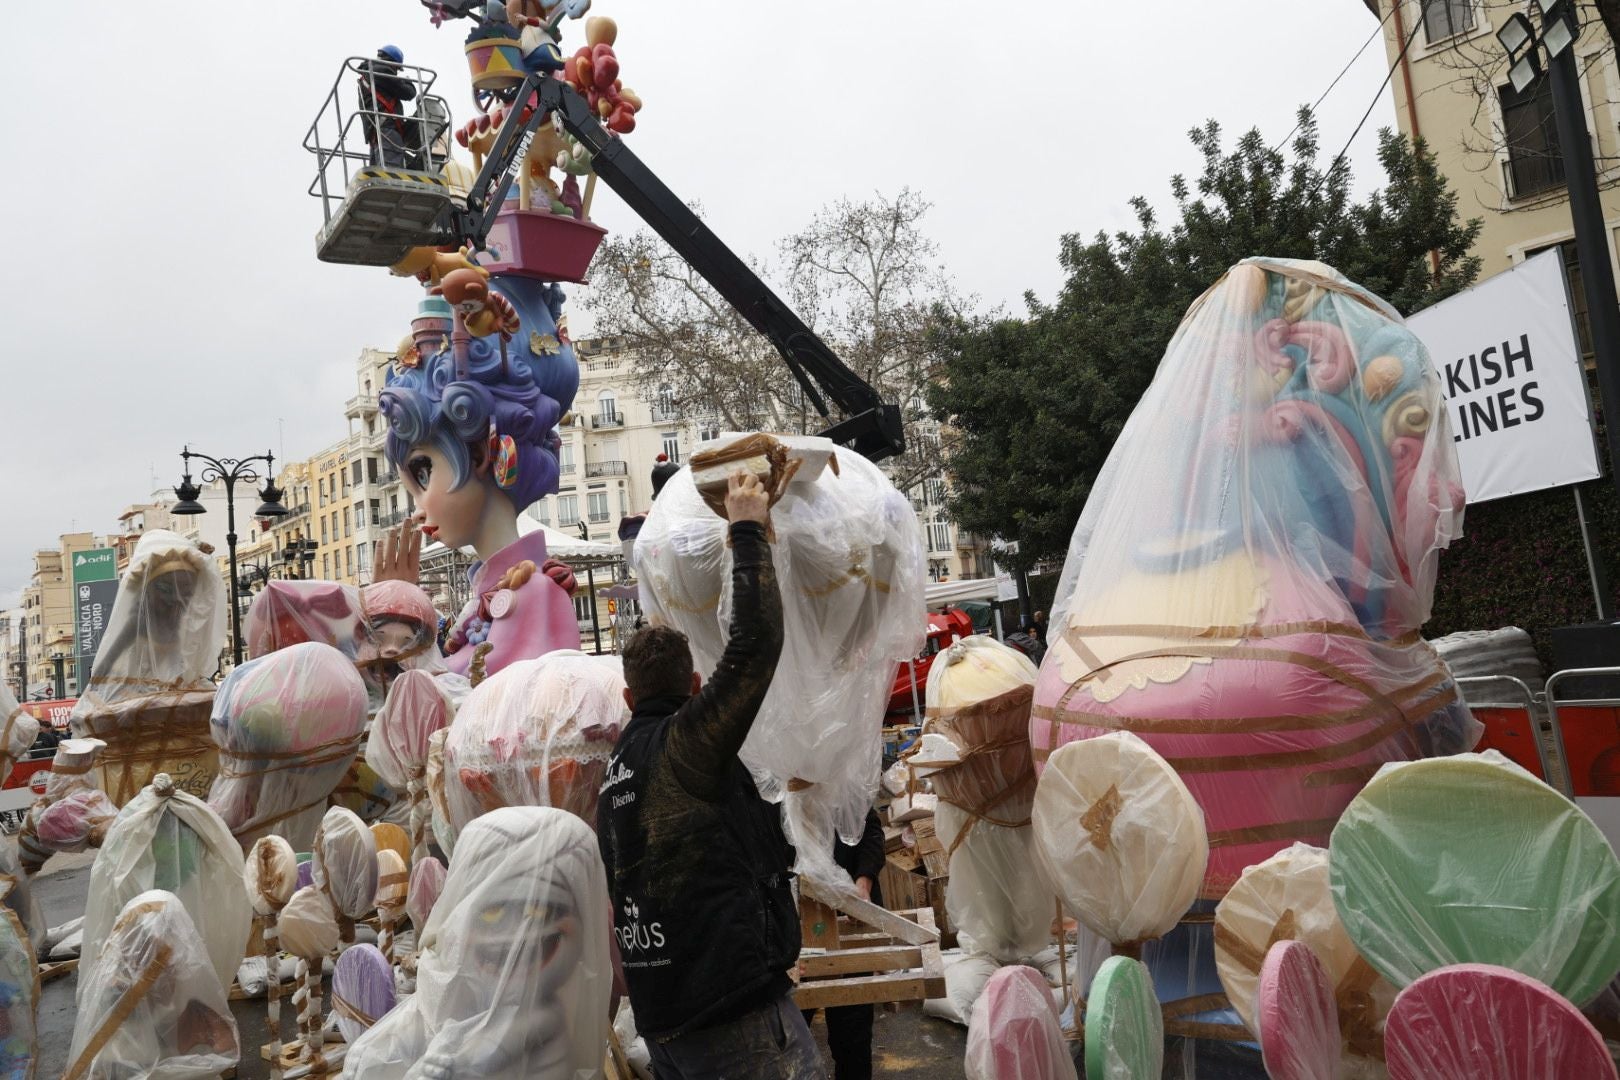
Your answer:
[1328,750,1620,1004]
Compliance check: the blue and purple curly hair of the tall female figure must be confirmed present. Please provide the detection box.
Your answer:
[377,275,580,512]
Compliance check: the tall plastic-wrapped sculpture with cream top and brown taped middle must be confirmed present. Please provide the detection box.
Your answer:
[912,636,1055,963]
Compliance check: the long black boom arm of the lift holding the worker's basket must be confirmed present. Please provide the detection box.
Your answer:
[455,74,906,461]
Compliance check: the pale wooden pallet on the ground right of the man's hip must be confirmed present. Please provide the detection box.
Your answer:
[794,886,944,1009]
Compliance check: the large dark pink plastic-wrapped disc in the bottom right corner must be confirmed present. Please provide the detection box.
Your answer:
[1387,963,1615,1080]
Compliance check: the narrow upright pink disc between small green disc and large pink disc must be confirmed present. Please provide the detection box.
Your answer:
[1257,941,1340,1080]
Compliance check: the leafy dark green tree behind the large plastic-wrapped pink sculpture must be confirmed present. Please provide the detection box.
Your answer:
[930,110,1481,568]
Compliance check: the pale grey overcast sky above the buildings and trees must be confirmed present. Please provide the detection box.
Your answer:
[0,0,1395,606]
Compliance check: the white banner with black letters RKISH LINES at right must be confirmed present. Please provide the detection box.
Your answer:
[1406,249,1602,502]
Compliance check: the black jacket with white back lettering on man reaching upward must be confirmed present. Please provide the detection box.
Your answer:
[596,521,799,1038]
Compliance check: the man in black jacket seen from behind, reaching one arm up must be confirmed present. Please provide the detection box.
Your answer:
[596,474,825,1080]
